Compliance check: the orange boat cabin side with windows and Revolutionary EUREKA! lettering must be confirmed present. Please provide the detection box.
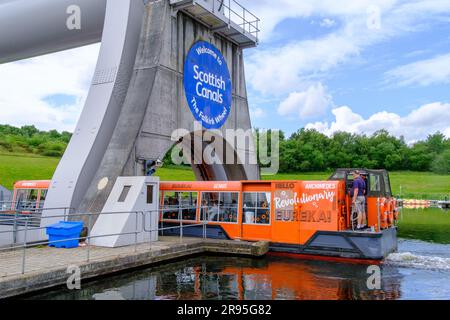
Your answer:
[160,181,348,244]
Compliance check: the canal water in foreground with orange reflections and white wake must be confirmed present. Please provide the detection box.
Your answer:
[31,209,450,300]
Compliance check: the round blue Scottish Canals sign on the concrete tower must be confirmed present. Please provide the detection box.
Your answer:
[184,41,232,129]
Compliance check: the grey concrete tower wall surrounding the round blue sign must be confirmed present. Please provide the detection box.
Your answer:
[80,1,259,216]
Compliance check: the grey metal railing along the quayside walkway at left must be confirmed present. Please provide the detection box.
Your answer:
[0,207,208,274]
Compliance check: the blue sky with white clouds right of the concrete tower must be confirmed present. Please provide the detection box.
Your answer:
[241,0,450,141]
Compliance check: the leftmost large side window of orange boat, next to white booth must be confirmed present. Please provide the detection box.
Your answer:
[162,192,198,221]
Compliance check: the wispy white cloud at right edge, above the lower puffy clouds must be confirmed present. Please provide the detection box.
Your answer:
[386,54,450,86]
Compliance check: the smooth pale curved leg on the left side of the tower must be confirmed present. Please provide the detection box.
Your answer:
[43,0,144,224]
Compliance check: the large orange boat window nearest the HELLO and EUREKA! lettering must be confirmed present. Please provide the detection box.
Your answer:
[242,192,271,224]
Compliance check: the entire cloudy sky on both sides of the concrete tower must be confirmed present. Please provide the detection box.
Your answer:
[0,0,450,143]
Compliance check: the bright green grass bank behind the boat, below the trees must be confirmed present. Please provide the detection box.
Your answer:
[0,153,450,199]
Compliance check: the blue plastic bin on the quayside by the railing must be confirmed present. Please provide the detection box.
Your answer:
[46,221,83,248]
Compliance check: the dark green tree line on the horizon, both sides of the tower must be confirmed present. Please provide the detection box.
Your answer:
[0,125,450,174]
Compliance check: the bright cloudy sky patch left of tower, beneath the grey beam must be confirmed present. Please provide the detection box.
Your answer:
[0,44,100,131]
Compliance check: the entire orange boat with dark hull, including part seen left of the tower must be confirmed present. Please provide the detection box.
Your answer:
[3,168,398,264]
